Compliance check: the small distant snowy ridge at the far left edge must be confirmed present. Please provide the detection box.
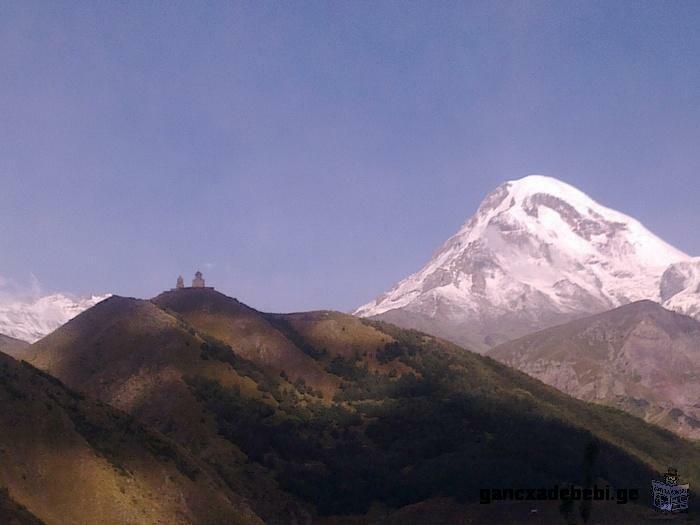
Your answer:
[0,294,109,343]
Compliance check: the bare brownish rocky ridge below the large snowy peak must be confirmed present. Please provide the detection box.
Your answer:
[488,301,700,439]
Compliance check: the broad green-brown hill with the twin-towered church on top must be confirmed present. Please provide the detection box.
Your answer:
[17,289,700,524]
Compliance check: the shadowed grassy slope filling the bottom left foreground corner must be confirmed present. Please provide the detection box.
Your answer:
[0,348,262,525]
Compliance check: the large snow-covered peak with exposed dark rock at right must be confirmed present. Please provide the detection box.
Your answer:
[355,175,700,350]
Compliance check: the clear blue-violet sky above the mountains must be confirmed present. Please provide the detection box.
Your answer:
[0,0,700,311]
